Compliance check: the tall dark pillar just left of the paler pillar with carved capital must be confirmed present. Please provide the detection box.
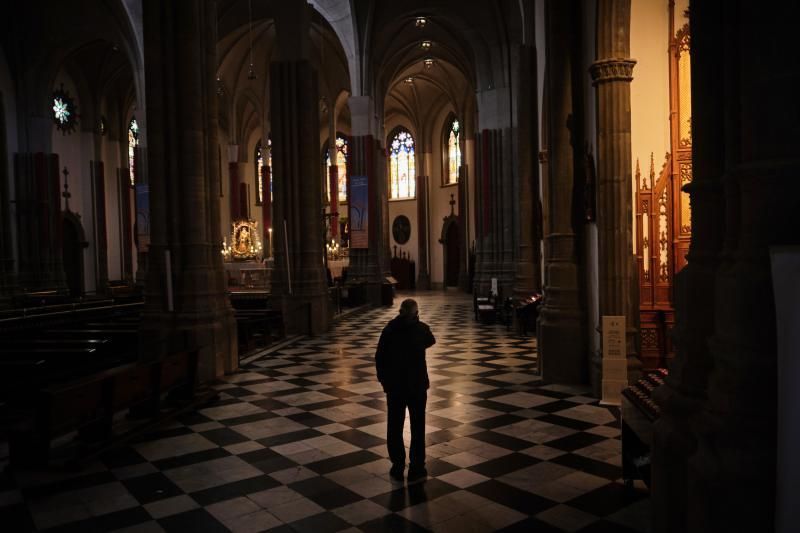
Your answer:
[538,0,588,383]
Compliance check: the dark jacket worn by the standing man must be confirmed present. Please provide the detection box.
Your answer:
[375,316,436,393]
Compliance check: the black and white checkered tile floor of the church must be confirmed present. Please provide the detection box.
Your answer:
[0,293,649,533]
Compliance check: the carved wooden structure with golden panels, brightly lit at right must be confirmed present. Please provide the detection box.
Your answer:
[635,17,692,368]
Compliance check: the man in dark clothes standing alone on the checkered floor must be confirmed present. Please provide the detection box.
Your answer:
[375,299,436,483]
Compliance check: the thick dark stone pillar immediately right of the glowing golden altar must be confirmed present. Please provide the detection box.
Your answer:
[270,2,329,334]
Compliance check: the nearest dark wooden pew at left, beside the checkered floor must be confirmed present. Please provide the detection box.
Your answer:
[9,351,197,466]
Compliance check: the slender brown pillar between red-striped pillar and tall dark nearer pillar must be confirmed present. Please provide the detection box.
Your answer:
[514,46,541,296]
